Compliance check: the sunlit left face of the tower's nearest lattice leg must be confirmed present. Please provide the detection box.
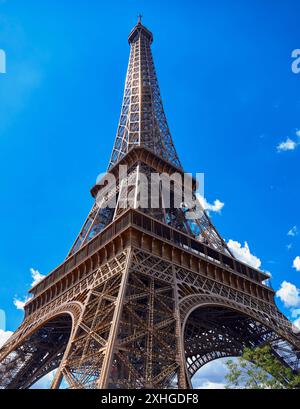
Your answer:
[47,250,130,389]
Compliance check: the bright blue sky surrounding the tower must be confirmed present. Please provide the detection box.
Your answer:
[0,0,300,388]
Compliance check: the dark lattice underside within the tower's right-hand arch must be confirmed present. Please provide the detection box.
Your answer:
[183,297,300,386]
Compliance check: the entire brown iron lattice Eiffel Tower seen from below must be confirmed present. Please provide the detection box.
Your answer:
[0,18,300,389]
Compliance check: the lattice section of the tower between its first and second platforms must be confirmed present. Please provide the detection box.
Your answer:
[68,163,232,256]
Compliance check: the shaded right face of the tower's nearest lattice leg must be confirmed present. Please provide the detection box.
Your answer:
[108,250,179,388]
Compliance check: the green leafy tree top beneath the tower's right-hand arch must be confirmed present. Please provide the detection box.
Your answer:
[226,345,300,389]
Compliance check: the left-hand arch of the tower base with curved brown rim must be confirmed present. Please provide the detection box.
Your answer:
[0,302,82,389]
